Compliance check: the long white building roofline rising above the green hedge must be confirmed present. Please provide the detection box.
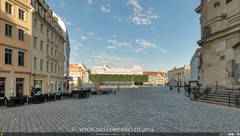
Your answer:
[90,65,143,75]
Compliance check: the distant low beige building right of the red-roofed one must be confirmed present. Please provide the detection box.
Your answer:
[168,65,190,86]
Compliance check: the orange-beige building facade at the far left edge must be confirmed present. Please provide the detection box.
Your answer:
[0,0,31,99]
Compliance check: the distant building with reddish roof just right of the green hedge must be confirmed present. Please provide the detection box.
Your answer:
[143,71,167,86]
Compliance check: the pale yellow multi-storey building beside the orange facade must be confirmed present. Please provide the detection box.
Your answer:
[31,0,65,93]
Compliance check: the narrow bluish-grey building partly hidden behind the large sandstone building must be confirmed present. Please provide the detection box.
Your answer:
[190,48,201,81]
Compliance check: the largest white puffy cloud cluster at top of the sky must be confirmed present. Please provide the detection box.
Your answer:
[127,0,158,25]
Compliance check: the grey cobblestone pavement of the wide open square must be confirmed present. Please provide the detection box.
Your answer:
[0,87,240,132]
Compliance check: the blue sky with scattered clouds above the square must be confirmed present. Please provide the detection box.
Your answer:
[46,0,200,71]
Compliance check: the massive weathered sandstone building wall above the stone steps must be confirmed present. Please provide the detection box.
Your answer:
[196,0,240,88]
